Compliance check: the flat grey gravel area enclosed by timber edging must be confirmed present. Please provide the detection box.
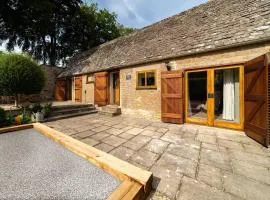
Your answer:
[0,129,121,200]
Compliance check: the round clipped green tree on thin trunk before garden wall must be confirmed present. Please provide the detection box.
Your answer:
[0,54,45,106]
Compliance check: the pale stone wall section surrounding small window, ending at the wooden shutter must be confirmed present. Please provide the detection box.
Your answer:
[120,63,166,118]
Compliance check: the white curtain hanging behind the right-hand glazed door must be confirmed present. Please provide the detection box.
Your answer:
[222,69,235,121]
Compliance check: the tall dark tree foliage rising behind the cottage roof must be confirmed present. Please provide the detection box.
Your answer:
[0,0,131,65]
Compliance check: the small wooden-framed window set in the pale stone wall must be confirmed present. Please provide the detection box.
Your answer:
[137,70,157,89]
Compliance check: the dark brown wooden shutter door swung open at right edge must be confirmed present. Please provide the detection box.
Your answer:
[244,55,269,146]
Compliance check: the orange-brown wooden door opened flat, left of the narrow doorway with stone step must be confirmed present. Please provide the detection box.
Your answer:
[95,72,109,106]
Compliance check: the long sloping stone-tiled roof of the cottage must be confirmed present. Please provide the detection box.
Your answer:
[60,0,270,77]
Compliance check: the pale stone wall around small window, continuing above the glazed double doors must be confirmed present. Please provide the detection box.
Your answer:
[120,43,270,119]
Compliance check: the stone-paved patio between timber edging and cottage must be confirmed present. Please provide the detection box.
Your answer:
[46,114,270,200]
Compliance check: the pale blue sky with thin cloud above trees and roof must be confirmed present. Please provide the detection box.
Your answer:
[86,0,207,28]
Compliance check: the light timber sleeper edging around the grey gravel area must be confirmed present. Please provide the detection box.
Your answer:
[0,123,153,200]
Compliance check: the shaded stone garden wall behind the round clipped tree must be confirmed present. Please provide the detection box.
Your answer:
[0,65,63,104]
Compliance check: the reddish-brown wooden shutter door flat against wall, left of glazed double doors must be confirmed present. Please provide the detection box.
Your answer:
[161,71,183,124]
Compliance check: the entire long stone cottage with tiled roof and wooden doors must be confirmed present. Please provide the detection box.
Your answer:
[55,0,270,145]
